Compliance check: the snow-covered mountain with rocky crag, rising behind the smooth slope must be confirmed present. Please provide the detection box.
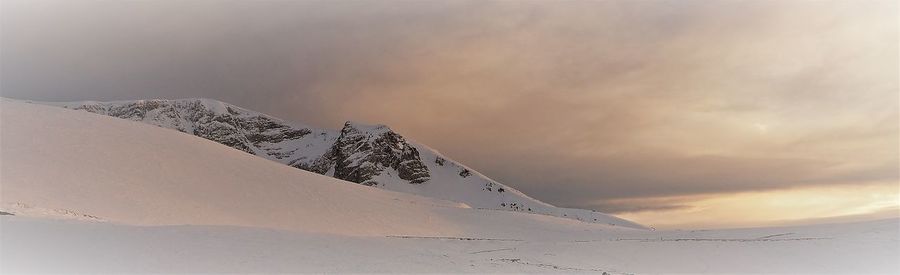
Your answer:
[41,99,638,226]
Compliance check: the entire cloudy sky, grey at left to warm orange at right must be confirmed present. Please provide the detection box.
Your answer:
[0,0,900,227]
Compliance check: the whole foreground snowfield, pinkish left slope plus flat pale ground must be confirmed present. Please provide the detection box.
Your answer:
[0,100,900,274]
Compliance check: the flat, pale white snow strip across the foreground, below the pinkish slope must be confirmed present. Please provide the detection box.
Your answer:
[0,216,900,274]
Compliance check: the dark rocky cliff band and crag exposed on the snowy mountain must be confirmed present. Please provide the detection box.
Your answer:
[67,99,431,186]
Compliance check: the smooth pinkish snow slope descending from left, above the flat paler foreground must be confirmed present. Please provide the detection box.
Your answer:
[0,100,636,236]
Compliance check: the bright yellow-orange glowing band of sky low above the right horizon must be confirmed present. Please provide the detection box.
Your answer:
[617,182,900,229]
